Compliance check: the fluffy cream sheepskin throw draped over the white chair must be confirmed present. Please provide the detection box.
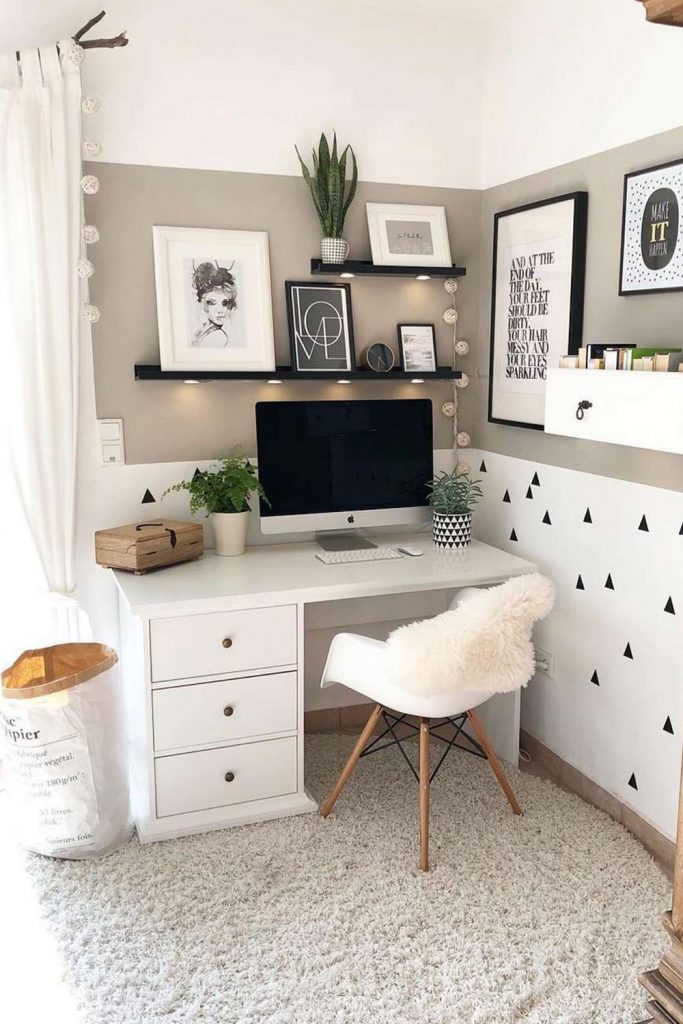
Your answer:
[386,573,555,696]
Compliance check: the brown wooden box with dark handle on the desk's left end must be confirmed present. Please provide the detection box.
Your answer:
[95,519,204,573]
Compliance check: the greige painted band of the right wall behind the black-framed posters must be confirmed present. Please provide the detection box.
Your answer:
[473,128,683,490]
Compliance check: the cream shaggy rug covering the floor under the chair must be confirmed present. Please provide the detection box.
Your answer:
[5,735,671,1024]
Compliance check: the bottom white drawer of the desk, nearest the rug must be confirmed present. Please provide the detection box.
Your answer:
[155,736,297,818]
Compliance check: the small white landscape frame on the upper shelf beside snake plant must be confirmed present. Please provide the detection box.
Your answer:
[366,203,451,266]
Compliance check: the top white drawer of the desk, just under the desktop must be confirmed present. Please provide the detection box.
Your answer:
[151,604,297,682]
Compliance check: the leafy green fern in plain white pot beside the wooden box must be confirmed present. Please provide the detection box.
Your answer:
[164,449,268,555]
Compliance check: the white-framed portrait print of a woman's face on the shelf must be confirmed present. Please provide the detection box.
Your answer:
[153,226,275,373]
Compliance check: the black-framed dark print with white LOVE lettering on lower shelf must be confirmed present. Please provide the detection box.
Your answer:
[285,281,355,374]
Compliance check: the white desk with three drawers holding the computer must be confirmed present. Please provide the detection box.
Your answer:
[115,532,536,842]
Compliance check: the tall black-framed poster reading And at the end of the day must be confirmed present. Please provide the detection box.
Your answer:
[488,191,588,430]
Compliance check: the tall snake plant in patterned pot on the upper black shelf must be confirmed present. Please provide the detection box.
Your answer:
[294,132,358,263]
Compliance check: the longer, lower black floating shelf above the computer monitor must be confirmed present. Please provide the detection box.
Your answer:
[135,364,462,384]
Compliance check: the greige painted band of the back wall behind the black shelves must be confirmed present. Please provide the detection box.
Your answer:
[86,163,481,463]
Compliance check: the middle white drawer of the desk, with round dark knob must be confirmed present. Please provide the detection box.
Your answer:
[152,672,297,753]
